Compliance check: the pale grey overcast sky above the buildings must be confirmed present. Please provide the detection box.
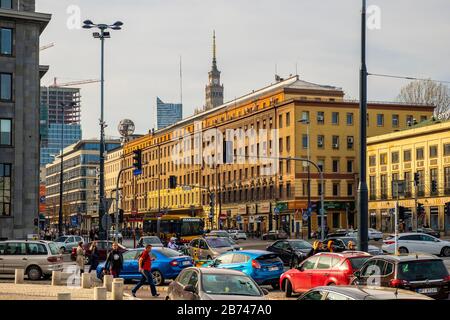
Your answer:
[36,0,450,138]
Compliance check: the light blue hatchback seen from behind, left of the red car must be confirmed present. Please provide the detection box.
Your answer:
[210,250,284,289]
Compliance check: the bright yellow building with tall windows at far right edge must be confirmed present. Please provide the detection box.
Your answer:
[367,121,450,233]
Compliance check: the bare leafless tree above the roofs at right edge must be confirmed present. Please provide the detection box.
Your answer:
[397,80,450,115]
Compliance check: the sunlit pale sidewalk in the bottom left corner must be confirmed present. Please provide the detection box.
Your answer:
[0,283,134,300]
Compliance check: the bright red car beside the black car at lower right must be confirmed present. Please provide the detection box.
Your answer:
[280,251,371,297]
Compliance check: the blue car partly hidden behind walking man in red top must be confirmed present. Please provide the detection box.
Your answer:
[97,248,193,286]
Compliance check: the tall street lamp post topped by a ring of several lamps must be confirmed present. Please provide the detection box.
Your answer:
[83,20,123,240]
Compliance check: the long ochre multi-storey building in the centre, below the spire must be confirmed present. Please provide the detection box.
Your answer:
[118,76,433,234]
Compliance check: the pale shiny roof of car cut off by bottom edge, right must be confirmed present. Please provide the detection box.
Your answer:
[312,286,433,300]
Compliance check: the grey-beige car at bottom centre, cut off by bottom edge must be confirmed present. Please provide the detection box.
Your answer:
[166,268,268,300]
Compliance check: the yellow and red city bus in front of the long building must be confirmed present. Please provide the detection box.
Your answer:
[143,215,204,243]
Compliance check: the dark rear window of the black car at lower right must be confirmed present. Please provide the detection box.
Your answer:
[398,260,448,281]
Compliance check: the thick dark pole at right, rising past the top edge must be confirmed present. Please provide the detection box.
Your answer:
[358,0,369,252]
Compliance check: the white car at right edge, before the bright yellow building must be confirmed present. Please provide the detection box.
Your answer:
[381,232,450,257]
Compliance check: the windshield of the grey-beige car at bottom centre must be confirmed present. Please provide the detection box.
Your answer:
[202,274,261,297]
